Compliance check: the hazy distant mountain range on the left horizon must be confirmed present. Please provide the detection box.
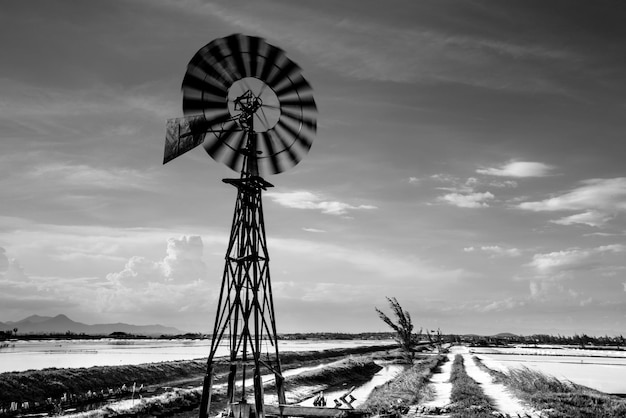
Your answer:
[0,315,185,335]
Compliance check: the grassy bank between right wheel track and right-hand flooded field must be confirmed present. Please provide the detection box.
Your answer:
[474,356,626,418]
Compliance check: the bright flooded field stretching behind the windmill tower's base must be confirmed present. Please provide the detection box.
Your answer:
[0,338,394,373]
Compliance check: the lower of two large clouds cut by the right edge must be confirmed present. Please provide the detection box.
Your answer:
[528,244,626,277]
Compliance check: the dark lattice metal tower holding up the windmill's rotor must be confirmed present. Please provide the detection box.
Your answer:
[200,125,286,418]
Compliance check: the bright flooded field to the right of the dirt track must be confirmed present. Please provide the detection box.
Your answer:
[471,346,626,395]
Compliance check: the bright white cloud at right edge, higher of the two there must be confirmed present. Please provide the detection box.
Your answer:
[518,177,626,226]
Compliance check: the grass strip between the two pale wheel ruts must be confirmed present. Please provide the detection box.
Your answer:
[449,354,495,418]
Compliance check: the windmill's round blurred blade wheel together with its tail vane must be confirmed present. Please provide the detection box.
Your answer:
[164,34,317,174]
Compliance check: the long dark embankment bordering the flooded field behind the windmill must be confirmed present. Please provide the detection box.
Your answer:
[0,346,393,414]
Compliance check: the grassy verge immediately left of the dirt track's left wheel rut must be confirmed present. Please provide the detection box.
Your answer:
[362,354,447,415]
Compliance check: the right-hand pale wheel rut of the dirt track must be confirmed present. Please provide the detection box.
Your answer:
[459,349,540,418]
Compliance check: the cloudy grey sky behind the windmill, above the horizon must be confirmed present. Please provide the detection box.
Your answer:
[0,0,626,336]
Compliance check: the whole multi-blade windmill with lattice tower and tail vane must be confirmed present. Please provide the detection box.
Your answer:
[163,34,317,418]
